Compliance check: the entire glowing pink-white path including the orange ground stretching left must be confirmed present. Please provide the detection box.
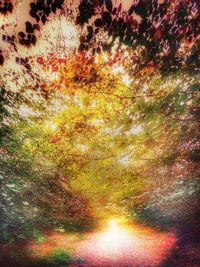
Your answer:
[28,225,176,267]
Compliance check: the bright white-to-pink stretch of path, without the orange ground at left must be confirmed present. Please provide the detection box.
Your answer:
[73,221,176,266]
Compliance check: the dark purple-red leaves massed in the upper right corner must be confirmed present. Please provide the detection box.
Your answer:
[77,0,199,74]
